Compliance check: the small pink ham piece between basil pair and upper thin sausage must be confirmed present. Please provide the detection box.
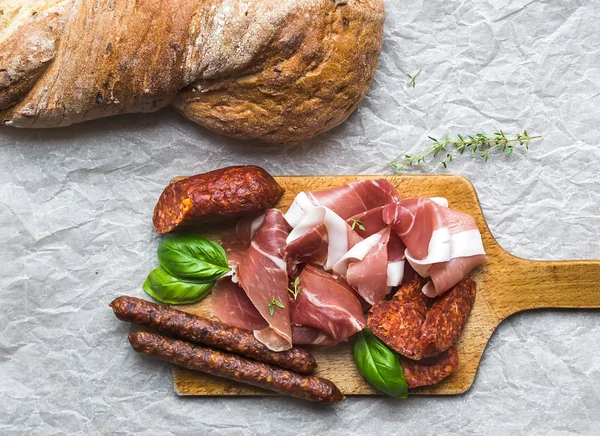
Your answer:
[210,278,269,330]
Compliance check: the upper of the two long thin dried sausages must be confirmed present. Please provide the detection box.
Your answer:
[110,296,317,373]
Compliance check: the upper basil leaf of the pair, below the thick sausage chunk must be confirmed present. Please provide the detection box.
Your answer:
[157,235,231,283]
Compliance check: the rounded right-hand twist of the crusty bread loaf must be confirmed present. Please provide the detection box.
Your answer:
[173,0,384,143]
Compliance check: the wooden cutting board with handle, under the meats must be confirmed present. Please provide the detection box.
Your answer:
[173,175,600,395]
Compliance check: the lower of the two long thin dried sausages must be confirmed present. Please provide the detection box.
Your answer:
[128,332,344,403]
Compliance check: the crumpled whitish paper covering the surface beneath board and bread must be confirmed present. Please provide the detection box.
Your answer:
[0,0,600,435]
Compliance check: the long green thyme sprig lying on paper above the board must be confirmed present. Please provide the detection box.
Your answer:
[392,130,541,173]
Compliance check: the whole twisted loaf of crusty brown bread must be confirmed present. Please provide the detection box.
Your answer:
[0,0,385,143]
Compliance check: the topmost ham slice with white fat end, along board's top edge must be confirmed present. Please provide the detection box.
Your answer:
[285,179,400,228]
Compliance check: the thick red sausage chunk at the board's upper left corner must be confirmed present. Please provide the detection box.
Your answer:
[152,165,283,233]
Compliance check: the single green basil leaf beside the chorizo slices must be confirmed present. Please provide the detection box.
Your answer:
[353,329,408,398]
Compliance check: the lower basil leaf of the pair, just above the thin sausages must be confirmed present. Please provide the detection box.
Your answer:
[142,266,216,304]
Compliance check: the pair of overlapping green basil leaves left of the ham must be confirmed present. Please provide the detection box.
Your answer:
[142,235,230,304]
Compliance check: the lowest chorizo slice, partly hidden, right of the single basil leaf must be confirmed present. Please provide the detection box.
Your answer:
[400,347,458,388]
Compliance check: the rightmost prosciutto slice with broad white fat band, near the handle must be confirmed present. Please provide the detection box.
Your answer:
[382,197,487,297]
